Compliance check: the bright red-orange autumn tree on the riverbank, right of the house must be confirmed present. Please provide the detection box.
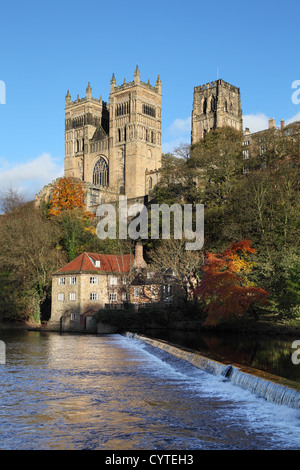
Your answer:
[198,240,268,325]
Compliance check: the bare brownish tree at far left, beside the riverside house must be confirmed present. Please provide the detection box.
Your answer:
[0,203,66,322]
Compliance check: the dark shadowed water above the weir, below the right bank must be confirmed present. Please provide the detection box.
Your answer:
[145,330,300,383]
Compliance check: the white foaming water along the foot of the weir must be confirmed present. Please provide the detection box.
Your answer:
[120,338,300,449]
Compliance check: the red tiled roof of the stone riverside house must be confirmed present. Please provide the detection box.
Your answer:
[57,252,134,273]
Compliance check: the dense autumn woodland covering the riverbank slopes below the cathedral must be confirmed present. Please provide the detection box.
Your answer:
[0,122,300,325]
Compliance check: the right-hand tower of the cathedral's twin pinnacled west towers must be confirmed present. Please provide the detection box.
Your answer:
[109,67,161,198]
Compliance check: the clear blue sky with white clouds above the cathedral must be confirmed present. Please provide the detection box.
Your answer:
[0,0,300,197]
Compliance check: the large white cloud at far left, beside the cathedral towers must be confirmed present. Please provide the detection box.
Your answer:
[0,153,64,199]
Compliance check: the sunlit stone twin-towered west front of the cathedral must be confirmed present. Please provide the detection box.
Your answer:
[65,67,162,205]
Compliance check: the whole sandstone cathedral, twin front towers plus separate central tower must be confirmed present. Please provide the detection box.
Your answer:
[36,71,251,212]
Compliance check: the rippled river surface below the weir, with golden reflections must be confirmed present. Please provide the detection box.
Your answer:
[0,332,300,450]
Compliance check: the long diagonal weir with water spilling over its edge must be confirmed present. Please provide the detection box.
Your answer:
[124,332,300,409]
